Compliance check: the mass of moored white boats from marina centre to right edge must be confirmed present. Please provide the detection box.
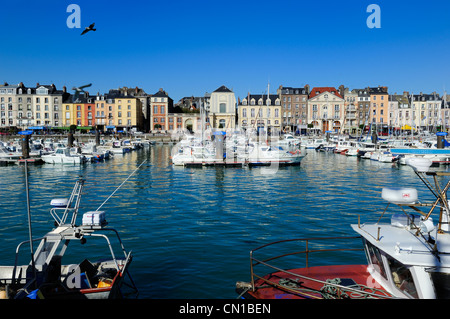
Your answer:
[171,132,450,167]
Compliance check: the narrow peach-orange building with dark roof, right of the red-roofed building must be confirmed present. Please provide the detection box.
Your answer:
[368,86,389,133]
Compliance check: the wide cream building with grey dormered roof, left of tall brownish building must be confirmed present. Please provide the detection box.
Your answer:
[238,93,283,135]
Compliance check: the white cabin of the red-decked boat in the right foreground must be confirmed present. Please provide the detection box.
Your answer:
[352,159,450,299]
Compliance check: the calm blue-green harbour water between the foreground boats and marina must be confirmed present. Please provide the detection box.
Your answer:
[0,146,438,299]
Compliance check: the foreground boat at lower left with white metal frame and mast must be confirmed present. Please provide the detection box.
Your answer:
[0,179,137,299]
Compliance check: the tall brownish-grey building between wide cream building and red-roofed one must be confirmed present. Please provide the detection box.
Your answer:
[277,85,309,133]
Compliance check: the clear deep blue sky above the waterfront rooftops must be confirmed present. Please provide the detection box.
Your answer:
[0,0,450,101]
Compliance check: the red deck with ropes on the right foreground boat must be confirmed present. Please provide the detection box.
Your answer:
[237,265,392,299]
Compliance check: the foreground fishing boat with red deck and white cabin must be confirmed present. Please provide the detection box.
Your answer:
[236,158,450,299]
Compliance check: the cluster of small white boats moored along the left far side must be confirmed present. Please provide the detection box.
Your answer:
[0,138,150,164]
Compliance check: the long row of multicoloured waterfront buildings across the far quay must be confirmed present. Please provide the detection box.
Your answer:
[0,83,450,134]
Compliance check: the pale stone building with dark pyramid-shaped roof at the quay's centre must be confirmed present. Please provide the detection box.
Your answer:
[208,85,236,129]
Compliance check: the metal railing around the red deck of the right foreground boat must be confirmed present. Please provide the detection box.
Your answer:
[248,236,390,298]
